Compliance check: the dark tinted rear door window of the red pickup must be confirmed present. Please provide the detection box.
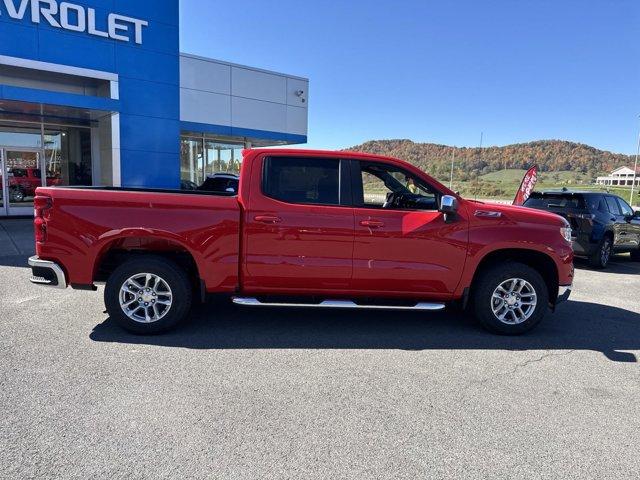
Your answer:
[262,157,340,205]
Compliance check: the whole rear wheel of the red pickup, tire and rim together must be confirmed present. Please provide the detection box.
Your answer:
[104,255,192,335]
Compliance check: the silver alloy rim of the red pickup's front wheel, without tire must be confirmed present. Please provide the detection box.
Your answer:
[491,278,537,325]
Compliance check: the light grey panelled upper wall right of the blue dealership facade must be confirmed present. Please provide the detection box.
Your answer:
[180,54,309,141]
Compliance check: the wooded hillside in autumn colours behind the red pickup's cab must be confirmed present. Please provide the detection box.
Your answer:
[347,140,633,181]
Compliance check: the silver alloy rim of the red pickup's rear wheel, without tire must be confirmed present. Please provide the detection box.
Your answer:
[120,273,173,323]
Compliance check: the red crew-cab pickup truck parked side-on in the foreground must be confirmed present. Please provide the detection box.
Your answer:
[29,149,573,334]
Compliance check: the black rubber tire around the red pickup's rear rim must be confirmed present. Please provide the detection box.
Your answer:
[104,255,193,335]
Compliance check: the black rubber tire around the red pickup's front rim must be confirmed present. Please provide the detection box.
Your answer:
[471,262,549,335]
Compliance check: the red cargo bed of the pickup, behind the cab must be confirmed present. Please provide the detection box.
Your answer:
[36,187,240,291]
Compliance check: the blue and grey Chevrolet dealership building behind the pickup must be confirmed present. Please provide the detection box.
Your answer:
[0,0,309,216]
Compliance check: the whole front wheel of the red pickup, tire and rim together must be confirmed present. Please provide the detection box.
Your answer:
[472,262,549,335]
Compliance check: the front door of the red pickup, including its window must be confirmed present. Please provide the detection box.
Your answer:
[351,161,469,298]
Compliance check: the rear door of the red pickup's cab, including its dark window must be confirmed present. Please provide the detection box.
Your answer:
[242,154,354,295]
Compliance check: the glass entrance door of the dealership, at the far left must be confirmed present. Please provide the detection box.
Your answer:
[0,148,44,215]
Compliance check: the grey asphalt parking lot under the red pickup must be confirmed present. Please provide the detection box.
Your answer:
[0,221,640,479]
